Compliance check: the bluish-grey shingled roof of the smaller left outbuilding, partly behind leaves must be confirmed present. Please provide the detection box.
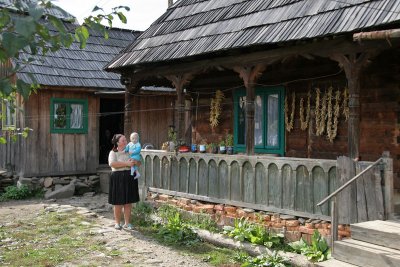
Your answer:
[0,0,141,90]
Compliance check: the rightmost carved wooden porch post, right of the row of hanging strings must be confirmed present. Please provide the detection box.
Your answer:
[331,53,370,159]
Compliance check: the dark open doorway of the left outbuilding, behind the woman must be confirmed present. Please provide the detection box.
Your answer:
[99,98,125,164]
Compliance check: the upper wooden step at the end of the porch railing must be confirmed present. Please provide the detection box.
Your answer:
[351,221,400,250]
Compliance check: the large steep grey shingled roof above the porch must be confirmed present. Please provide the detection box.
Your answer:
[107,0,400,70]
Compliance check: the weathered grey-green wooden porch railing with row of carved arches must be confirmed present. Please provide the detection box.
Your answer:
[140,150,390,223]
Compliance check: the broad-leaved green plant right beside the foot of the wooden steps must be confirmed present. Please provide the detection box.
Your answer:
[289,230,331,262]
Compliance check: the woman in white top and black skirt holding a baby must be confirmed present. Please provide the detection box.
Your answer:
[108,134,140,230]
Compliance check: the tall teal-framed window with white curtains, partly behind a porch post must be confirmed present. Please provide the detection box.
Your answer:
[234,88,285,155]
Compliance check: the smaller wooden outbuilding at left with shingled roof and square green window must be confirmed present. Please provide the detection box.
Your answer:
[0,3,140,177]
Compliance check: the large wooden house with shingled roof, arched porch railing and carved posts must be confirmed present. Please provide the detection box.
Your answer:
[106,0,400,225]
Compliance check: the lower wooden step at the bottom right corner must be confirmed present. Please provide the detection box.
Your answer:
[333,239,400,267]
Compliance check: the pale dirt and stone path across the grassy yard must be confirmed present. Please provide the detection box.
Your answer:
[0,194,210,267]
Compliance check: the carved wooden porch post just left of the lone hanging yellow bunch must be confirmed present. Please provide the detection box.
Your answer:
[166,74,192,147]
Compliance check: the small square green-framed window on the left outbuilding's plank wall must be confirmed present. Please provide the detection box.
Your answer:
[50,98,88,133]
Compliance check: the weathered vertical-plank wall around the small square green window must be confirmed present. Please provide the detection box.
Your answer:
[16,89,99,177]
